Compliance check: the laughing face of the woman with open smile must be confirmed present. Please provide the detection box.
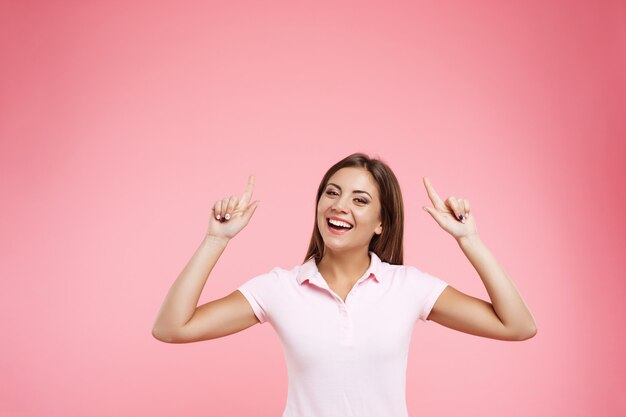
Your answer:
[317,167,382,251]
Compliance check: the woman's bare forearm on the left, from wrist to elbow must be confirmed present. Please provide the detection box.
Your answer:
[152,236,228,335]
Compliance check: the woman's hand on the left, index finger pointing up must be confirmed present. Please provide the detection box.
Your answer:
[207,175,260,240]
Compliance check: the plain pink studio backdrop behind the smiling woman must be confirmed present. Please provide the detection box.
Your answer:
[0,1,626,417]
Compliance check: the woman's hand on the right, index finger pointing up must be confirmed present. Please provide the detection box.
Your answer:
[422,177,478,240]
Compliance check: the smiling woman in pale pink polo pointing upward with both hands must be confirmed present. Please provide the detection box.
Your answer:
[153,153,536,417]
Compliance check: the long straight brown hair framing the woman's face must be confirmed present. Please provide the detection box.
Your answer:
[304,152,404,265]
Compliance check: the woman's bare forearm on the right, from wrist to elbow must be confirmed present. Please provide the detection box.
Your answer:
[458,235,536,334]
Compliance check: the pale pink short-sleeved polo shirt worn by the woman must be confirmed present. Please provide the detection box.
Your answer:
[237,252,448,417]
